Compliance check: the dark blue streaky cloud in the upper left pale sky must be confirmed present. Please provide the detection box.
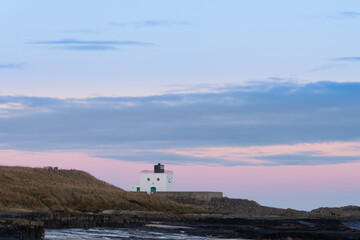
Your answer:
[29,39,155,51]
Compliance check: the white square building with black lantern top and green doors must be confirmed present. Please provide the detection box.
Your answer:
[130,163,173,194]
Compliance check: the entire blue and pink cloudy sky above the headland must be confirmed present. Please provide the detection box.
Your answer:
[0,0,360,210]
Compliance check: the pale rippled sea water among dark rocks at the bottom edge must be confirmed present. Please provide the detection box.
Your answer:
[45,228,235,240]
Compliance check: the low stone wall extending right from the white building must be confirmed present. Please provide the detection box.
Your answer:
[153,192,223,201]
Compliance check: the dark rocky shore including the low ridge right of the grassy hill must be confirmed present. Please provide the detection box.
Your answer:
[0,195,360,240]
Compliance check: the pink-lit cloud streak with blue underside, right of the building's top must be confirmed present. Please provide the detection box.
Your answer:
[153,141,360,165]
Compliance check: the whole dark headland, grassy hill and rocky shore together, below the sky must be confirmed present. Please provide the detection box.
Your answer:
[0,167,360,239]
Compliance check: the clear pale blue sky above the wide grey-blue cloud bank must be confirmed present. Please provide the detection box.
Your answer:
[0,0,360,98]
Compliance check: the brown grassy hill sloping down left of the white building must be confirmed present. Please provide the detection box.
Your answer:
[0,166,201,212]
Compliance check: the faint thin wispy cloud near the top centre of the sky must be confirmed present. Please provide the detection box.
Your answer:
[109,20,189,28]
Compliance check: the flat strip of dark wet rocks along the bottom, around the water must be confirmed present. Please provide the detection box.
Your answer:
[0,211,360,240]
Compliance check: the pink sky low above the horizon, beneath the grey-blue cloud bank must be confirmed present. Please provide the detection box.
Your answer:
[0,142,360,210]
